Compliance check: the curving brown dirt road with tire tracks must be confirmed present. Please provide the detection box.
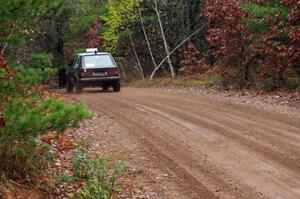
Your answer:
[74,88,300,199]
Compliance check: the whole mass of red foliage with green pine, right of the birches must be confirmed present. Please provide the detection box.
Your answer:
[182,0,300,90]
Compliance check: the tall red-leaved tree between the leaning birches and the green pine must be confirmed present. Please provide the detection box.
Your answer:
[202,0,249,87]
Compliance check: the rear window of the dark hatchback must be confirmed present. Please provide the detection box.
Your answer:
[83,55,115,68]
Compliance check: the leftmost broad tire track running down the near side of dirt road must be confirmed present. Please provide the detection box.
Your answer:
[79,96,260,199]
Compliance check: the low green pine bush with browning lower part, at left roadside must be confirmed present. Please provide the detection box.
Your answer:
[0,97,91,179]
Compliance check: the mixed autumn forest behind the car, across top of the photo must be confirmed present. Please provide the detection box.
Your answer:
[1,0,300,90]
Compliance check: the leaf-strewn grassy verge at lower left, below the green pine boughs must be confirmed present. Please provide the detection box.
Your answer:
[0,134,127,199]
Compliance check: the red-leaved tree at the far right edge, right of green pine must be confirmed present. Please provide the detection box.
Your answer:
[250,0,300,89]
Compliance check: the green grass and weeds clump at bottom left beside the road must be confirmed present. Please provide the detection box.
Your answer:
[59,140,127,199]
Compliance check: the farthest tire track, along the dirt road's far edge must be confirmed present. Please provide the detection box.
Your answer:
[128,88,300,130]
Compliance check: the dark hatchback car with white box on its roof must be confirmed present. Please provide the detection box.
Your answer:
[67,49,121,93]
